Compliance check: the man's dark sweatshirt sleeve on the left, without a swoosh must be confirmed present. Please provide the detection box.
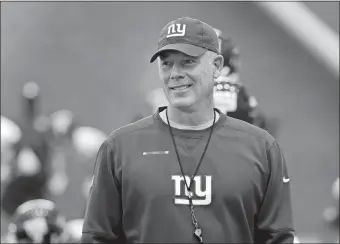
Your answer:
[81,141,123,244]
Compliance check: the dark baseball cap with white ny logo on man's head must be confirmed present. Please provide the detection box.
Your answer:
[150,17,219,63]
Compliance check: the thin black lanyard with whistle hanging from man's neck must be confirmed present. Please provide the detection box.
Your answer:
[166,109,216,243]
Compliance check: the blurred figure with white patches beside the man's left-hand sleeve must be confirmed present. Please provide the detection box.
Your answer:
[48,109,107,219]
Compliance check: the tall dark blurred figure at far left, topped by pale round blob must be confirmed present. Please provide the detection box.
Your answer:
[2,82,50,219]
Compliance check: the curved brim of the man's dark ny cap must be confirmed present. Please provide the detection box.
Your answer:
[150,43,207,63]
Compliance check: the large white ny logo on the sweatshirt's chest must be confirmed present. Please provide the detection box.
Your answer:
[171,175,212,205]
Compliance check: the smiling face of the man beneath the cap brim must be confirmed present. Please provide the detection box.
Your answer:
[159,51,216,109]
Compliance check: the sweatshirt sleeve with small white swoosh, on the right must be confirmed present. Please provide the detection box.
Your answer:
[255,142,294,243]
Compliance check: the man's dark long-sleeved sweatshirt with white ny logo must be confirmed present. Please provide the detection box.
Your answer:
[83,107,293,243]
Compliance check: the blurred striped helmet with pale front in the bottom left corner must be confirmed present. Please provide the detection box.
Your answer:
[4,199,65,244]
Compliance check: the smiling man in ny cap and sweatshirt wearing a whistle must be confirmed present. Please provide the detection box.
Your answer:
[82,17,294,243]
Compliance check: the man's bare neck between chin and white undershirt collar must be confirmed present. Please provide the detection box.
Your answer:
[168,99,214,126]
